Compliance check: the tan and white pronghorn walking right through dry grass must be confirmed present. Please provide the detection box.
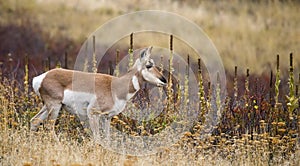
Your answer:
[31,47,167,131]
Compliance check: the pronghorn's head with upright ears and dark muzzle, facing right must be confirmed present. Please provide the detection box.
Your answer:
[134,46,167,86]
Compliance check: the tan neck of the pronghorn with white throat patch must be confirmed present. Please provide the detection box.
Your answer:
[112,69,144,101]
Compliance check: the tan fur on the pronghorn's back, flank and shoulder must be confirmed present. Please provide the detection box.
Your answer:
[40,69,135,112]
